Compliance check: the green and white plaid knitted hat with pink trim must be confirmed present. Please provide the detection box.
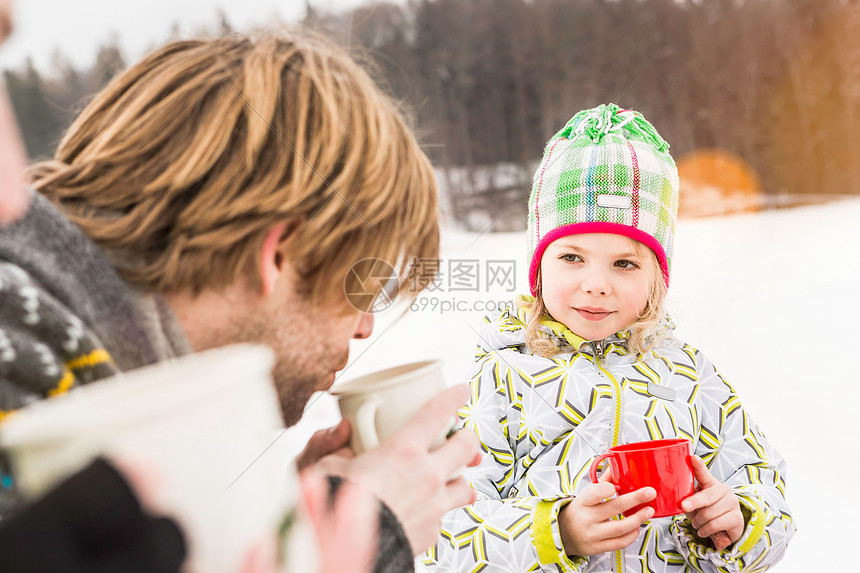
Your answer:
[528,104,678,294]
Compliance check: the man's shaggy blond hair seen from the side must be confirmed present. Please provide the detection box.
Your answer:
[31,31,439,303]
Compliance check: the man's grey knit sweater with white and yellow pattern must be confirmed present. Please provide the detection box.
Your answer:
[0,193,190,515]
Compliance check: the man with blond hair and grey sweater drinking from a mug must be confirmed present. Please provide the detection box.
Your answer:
[0,25,477,571]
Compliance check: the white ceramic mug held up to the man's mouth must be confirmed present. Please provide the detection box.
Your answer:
[331,360,456,454]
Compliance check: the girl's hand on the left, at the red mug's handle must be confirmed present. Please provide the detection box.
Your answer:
[558,470,657,557]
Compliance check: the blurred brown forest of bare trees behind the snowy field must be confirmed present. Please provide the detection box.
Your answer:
[5,0,860,228]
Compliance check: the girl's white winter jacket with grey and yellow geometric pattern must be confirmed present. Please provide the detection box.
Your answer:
[419,305,795,573]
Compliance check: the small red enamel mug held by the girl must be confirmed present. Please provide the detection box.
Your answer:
[589,438,696,517]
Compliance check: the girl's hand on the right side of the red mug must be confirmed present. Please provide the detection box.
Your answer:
[681,456,745,543]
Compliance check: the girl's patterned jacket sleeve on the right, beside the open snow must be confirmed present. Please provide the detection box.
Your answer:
[671,354,795,573]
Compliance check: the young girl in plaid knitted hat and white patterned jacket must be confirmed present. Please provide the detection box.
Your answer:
[423,104,795,572]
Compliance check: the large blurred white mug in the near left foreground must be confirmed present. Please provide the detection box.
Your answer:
[0,345,300,573]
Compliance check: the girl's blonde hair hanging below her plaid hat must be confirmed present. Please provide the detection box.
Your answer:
[526,239,667,358]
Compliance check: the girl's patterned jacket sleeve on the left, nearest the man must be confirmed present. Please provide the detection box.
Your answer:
[419,353,586,573]
